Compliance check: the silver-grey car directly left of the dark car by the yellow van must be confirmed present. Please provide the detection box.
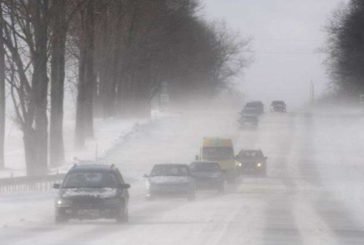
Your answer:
[144,164,195,200]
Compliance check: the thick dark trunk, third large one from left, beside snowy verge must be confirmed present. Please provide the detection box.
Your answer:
[76,0,96,148]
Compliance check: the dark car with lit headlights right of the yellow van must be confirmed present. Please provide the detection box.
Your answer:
[236,150,267,175]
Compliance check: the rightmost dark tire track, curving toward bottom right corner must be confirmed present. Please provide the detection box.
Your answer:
[299,117,364,245]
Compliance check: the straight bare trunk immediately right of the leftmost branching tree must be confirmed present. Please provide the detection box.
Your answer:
[50,0,67,166]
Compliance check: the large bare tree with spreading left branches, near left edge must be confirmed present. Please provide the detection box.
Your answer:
[2,0,49,175]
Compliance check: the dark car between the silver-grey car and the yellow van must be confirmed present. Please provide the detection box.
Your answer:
[190,161,225,192]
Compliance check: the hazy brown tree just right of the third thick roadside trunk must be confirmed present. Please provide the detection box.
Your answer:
[95,0,125,118]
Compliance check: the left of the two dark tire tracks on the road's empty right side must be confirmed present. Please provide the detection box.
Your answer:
[242,115,303,245]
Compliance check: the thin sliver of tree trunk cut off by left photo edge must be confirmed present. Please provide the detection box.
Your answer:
[0,0,6,169]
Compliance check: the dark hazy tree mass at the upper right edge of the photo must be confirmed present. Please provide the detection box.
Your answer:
[327,0,364,101]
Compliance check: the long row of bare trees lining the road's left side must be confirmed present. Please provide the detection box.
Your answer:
[0,0,247,175]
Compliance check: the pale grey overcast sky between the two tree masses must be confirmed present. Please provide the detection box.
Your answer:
[201,0,348,107]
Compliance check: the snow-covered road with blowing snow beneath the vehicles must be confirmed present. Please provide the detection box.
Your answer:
[0,112,364,245]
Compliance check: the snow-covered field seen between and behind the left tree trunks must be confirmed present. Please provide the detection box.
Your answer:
[0,117,149,178]
